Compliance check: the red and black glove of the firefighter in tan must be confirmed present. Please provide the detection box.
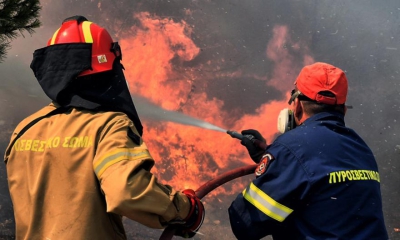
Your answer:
[174,189,205,238]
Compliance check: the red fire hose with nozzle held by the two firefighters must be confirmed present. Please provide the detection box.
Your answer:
[159,131,266,240]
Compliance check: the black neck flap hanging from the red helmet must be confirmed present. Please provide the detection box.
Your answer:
[30,16,143,136]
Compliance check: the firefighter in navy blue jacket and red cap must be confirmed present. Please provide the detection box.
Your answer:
[229,62,388,240]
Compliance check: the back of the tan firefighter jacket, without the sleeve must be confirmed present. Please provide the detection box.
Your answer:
[5,104,126,239]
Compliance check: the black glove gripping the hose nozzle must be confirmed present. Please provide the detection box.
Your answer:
[240,129,267,163]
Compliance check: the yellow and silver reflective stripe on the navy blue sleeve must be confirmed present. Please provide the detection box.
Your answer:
[242,183,293,222]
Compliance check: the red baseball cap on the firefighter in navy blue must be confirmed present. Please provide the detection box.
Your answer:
[294,62,348,105]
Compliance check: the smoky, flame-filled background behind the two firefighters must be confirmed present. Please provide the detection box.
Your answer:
[0,0,400,239]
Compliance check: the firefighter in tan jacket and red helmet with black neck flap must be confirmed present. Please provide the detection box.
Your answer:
[4,16,204,239]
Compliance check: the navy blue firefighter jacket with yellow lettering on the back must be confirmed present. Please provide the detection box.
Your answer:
[229,113,388,240]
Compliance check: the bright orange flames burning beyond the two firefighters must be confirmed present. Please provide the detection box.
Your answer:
[120,13,312,195]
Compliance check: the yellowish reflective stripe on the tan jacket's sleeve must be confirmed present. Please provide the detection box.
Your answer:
[93,148,151,178]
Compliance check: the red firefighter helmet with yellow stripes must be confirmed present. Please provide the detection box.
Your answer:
[47,16,122,76]
